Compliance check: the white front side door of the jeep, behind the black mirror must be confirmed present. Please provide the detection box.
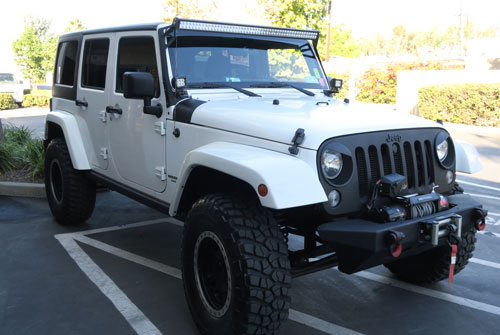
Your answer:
[108,32,167,192]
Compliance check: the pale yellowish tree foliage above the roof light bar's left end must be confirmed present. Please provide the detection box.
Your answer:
[163,0,218,22]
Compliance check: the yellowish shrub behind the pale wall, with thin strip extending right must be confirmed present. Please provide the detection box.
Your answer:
[356,61,464,104]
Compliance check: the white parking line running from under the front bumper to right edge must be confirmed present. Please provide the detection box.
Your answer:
[354,271,500,315]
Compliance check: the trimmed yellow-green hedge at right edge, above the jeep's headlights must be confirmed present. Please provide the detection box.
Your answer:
[418,84,500,127]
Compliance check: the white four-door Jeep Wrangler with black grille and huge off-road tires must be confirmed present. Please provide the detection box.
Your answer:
[45,19,487,334]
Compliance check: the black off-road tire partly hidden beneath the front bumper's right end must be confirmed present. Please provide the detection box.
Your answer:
[385,228,477,284]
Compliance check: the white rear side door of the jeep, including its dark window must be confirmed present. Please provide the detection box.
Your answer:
[75,34,114,170]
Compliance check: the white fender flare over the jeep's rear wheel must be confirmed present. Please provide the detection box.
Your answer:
[45,111,90,170]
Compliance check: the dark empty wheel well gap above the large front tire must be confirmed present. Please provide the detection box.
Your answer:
[176,166,259,219]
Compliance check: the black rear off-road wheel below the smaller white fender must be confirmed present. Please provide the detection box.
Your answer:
[45,138,95,225]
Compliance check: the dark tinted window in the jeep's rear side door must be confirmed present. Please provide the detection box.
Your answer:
[82,39,109,90]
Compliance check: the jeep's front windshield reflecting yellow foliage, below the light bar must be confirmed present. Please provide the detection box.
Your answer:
[169,36,328,89]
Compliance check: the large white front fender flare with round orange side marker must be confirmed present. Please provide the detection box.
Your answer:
[170,142,327,216]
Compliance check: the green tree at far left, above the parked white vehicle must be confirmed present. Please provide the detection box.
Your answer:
[12,17,57,82]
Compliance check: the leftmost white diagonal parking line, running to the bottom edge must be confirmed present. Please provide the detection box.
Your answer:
[55,234,161,335]
